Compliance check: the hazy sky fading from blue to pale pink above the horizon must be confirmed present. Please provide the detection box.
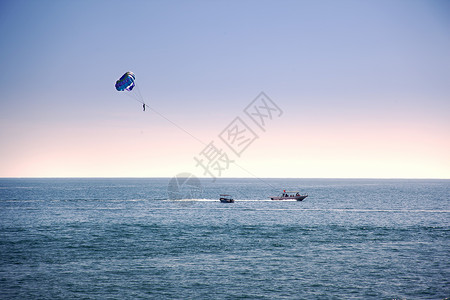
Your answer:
[0,0,450,179]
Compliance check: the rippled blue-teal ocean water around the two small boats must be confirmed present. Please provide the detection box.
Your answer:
[0,178,450,299]
